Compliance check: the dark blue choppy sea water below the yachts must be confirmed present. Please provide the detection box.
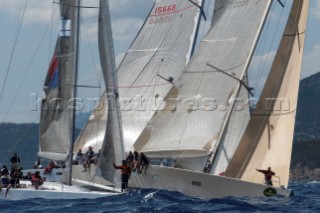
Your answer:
[0,182,320,213]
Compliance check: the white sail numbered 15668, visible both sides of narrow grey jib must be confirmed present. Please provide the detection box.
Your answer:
[74,0,202,156]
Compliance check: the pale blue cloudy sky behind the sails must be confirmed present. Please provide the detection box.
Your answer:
[0,0,320,123]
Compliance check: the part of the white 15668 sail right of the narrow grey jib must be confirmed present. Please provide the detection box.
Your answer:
[118,0,202,151]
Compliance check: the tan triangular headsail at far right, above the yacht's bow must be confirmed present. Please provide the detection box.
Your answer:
[225,0,309,185]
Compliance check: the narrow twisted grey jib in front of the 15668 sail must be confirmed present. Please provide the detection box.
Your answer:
[98,0,124,188]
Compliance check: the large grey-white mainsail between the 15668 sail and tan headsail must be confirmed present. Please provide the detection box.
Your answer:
[134,0,271,167]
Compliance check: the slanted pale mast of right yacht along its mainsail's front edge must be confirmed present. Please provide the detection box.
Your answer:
[210,0,272,169]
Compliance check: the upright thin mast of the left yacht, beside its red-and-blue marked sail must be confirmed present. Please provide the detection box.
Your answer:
[67,0,81,186]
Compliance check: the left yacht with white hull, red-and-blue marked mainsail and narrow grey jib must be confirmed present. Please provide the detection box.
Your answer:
[0,0,123,200]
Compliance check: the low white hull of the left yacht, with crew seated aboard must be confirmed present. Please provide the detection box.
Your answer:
[0,166,121,200]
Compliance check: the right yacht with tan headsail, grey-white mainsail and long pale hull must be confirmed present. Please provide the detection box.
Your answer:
[126,0,309,198]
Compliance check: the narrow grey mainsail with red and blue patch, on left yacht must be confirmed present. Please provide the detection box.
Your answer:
[39,0,77,160]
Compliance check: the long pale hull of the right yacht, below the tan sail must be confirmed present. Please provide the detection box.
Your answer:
[129,166,291,198]
